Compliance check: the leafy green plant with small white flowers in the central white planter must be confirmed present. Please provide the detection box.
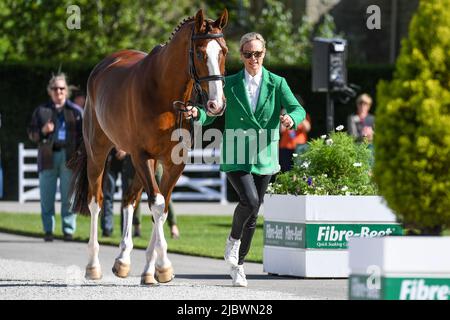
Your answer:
[269,127,377,195]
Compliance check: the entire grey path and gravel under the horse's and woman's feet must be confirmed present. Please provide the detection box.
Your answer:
[0,233,347,301]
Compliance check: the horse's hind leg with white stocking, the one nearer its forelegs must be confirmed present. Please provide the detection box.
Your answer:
[112,176,142,278]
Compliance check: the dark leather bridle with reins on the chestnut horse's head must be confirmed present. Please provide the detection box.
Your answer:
[172,26,225,147]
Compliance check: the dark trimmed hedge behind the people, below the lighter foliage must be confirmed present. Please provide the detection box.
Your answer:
[0,63,393,200]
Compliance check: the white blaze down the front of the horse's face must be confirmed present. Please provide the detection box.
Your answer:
[206,40,223,107]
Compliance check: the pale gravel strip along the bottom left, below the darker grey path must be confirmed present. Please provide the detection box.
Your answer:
[0,259,299,300]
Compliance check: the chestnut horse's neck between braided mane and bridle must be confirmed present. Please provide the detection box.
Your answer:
[143,25,191,107]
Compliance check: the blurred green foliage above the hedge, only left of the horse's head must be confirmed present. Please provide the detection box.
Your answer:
[0,0,232,62]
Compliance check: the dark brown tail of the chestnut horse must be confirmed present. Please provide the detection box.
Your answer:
[67,141,90,216]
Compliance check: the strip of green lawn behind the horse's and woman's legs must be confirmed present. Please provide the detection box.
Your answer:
[0,212,263,263]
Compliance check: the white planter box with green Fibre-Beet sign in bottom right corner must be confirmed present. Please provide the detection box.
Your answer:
[349,237,450,300]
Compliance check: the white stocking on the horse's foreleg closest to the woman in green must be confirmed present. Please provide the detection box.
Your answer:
[151,193,172,268]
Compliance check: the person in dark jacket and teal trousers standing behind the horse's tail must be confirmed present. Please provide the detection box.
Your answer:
[27,73,83,241]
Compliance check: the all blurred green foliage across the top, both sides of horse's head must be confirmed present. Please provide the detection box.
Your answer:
[0,0,335,64]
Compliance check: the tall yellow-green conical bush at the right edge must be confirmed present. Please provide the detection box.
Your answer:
[374,0,450,233]
